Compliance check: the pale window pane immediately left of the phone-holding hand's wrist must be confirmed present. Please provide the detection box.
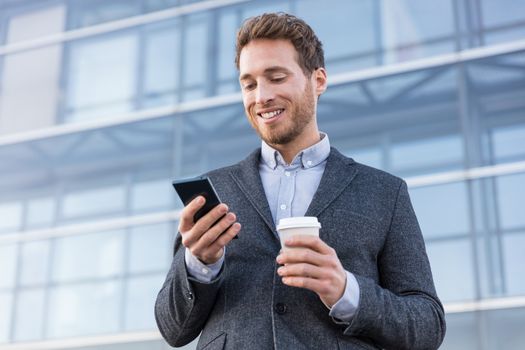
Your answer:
[129,223,175,274]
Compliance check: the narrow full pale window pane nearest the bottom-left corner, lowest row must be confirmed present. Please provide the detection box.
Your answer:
[14,288,45,341]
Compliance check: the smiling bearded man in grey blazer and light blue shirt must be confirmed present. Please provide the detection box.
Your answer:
[155,13,445,349]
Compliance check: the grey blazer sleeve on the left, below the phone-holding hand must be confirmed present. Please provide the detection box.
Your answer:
[155,235,223,346]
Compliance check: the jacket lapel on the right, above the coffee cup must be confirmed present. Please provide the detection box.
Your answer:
[305,147,357,217]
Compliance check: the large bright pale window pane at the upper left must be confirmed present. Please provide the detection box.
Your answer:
[65,34,138,122]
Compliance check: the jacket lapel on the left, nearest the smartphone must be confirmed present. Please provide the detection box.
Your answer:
[230,148,277,234]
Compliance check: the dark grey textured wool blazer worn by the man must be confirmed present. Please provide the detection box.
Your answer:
[155,148,445,350]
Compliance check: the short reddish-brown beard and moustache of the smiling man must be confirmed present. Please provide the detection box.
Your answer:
[249,80,315,145]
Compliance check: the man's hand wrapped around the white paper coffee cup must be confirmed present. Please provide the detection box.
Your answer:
[277,235,346,308]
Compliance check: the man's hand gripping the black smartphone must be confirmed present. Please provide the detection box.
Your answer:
[179,196,241,265]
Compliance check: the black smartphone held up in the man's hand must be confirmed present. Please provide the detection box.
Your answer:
[173,177,221,222]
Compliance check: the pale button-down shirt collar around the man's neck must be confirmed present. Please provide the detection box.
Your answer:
[261,132,330,169]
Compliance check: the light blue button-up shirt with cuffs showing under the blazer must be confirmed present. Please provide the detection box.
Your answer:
[185,133,359,323]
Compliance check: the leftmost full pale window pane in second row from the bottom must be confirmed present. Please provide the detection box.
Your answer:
[20,240,51,286]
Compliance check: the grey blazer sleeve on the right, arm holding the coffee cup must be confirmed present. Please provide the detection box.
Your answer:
[344,181,445,350]
